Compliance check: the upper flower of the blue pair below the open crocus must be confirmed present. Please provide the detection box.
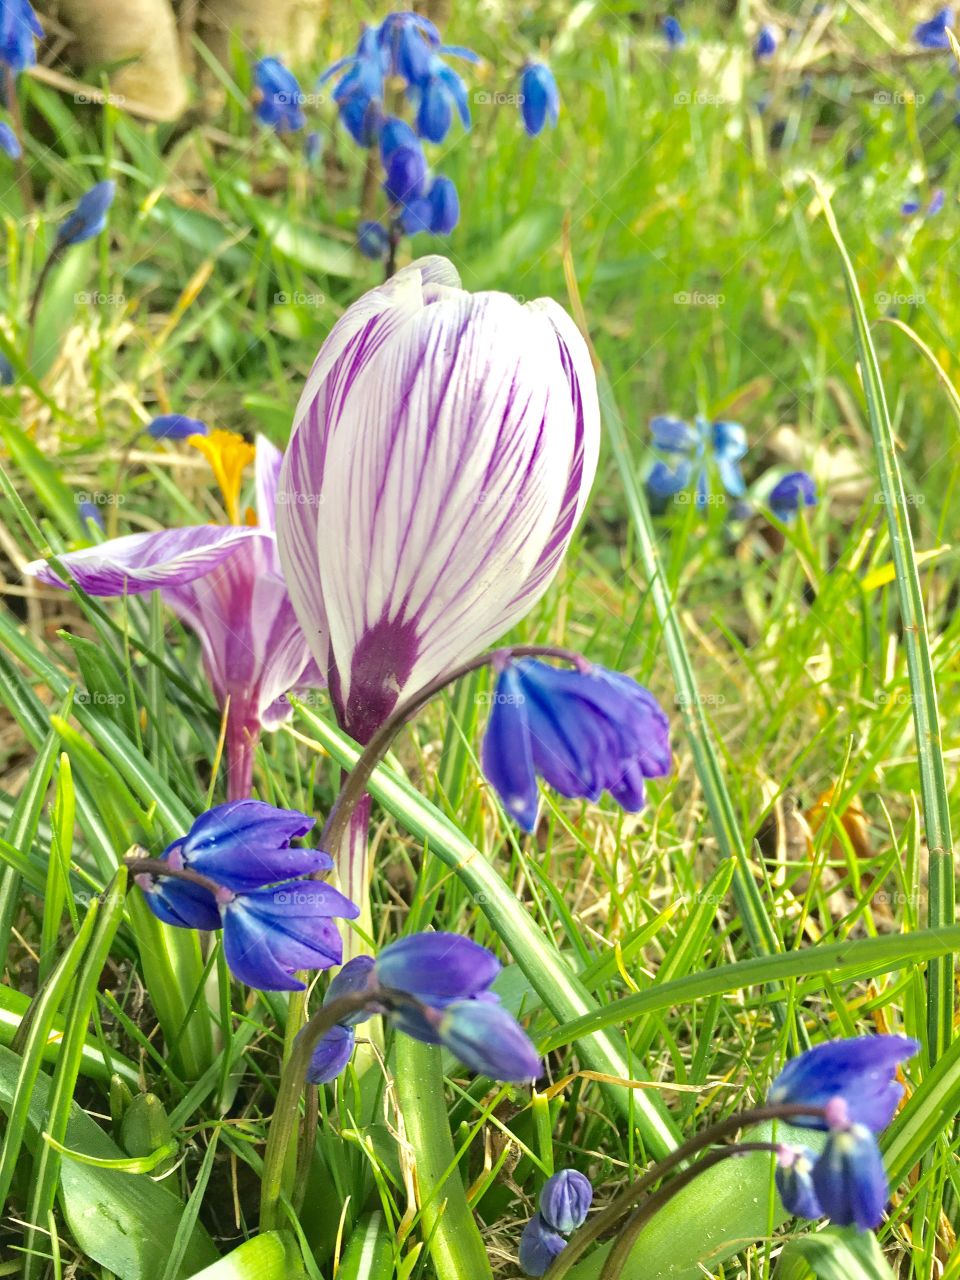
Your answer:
[164,800,321,893]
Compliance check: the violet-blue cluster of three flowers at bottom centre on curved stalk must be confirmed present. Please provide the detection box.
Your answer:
[307,933,543,1084]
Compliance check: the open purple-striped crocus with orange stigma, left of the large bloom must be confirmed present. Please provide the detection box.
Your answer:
[24,433,320,800]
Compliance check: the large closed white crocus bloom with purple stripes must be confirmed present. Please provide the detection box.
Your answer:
[276,257,600,900]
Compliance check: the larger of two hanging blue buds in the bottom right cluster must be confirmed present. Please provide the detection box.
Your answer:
[813,1124,890,1231]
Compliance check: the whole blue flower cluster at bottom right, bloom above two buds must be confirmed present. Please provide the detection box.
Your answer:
[767,1036,920,1231]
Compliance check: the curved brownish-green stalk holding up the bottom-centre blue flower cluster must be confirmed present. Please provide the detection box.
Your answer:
[260,992,370,1231]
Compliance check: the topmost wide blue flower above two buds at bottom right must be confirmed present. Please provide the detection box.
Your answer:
[767,1036,920,1133]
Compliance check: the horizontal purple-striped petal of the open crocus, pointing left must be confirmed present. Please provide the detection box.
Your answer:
[23,525,262,595]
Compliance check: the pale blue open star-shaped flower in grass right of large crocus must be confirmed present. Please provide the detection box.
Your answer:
[646,415,746,509]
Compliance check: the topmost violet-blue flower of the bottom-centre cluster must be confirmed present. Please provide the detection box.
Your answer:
[374,933,500,1006]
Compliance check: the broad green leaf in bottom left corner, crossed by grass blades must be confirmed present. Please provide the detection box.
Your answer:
[0,1047,216,1280]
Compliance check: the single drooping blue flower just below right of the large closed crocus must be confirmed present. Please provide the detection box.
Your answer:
[483,658,671,831]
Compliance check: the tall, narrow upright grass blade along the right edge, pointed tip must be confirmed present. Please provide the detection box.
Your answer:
[813,178,956,1061]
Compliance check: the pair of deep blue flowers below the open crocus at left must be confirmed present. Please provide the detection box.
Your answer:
[136,800,360,991]
